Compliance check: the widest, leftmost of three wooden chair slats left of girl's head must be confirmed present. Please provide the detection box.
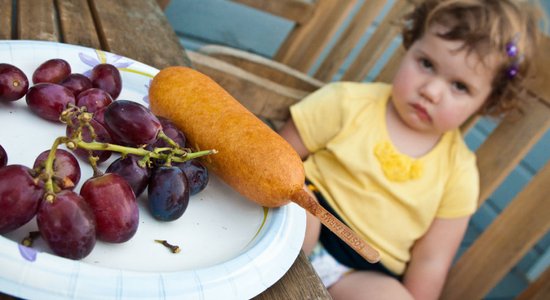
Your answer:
[274,0,357,73]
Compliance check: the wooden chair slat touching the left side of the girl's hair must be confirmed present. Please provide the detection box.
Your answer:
[342,0,410,81]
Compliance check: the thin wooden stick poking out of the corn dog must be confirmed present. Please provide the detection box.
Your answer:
[291,187,380,263]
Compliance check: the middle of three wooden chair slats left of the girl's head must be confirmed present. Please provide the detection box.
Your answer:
[314,0,386,82]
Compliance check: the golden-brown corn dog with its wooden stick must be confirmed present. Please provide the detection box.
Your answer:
[149,67,379,262]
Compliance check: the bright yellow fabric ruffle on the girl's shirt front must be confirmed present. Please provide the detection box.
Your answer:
[374,141,424,181]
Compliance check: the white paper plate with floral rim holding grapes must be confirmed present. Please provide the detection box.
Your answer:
[0,41,305,299]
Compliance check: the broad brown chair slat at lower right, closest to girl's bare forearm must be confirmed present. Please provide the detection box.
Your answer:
[442,163,550,300]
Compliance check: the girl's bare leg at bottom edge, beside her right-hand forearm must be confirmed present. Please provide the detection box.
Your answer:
[328,271,413,300]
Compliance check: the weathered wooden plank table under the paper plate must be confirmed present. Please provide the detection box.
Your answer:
[0,0,330,299]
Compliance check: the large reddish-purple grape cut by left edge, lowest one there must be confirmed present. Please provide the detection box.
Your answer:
[0,165,44,234]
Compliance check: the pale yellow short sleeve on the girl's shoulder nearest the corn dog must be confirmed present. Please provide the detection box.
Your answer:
[290,82,346,152]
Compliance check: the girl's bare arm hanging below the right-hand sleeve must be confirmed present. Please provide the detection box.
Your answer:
[403,217,470,299]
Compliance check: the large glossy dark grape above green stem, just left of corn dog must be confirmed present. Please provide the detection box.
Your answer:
[104,100,162,146]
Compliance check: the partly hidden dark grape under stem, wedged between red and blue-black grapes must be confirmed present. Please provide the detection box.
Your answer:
[105,155,151,197]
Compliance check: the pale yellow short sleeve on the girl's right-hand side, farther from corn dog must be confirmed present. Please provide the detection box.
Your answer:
[436,152,479,218]
